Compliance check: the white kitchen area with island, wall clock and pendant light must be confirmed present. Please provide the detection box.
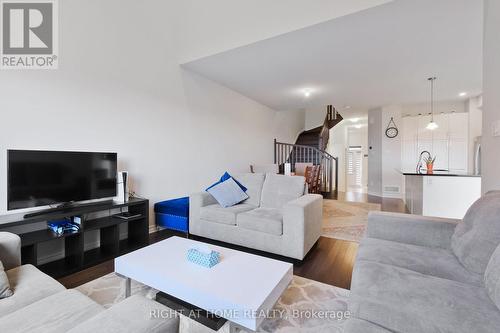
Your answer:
[368,92,482,218]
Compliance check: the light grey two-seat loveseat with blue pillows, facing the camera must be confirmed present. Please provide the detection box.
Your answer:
[189,173,323,260]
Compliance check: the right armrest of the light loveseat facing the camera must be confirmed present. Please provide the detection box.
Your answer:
[283,194,323,258]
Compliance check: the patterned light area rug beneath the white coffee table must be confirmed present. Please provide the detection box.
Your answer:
[77,273,349,333]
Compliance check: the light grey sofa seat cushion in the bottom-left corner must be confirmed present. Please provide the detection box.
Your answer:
[0,290,104,333]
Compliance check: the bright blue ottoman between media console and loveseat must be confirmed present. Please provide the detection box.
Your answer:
[155,197,189,233]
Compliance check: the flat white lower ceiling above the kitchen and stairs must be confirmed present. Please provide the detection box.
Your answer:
[183,0,483,110]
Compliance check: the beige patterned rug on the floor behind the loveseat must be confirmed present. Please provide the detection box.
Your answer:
[322,199,381,243]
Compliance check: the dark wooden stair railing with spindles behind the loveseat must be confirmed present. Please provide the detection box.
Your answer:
[274,139,339,192]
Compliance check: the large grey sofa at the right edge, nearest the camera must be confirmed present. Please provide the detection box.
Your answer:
[345,192,500,333]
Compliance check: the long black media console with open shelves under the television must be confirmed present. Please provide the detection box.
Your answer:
[0,198,149,278]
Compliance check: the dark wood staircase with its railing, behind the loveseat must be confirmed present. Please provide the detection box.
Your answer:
[274,105,343,192]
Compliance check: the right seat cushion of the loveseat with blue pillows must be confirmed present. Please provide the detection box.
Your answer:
[236,208,283,236]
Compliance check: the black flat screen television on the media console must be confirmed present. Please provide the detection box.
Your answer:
[7,150,117,210]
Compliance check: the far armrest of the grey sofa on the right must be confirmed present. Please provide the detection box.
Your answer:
[366,212,460,249]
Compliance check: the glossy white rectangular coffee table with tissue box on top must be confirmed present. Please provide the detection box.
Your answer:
[115,237,293,331]
